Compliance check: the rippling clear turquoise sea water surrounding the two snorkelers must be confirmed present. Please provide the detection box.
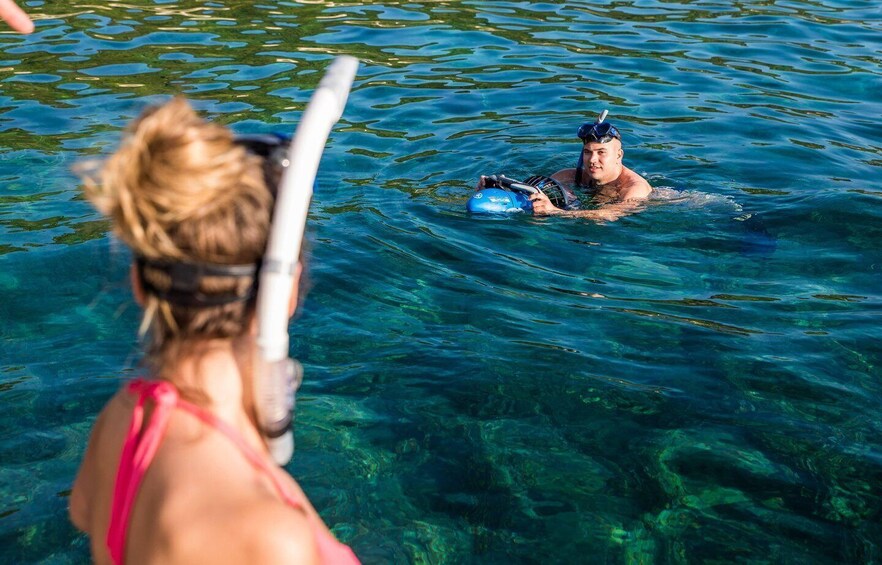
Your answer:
[0,0,882,563]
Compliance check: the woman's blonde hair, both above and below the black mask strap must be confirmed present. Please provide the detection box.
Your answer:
[84,98,273,375]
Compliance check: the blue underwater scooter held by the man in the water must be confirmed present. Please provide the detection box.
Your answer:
[466,174,578,214]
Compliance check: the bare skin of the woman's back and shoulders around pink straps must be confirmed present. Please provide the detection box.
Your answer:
[71,376,330,563]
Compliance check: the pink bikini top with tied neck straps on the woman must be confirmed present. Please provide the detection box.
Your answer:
[107,379,359,564]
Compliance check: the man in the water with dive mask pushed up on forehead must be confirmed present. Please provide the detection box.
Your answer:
[530,110,652,222]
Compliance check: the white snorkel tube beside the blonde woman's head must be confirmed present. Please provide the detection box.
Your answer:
[254,55,358,465]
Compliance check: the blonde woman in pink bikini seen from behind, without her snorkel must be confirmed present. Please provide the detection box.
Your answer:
[70,99,358,563]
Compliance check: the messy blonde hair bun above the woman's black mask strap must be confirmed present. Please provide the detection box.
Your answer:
[85,98,268,263]
